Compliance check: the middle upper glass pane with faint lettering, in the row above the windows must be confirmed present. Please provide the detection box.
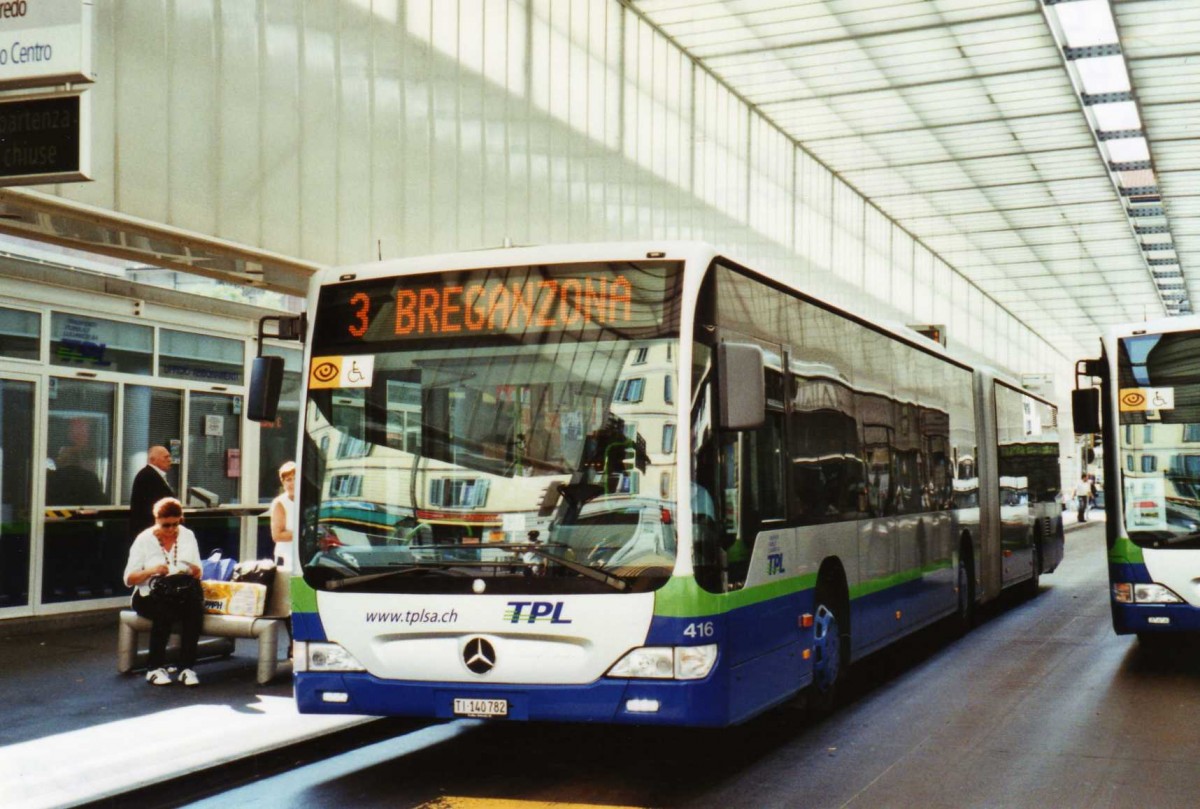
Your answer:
[50,312,154,374]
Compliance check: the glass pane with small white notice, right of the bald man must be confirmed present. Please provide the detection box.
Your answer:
[187,394,241,505]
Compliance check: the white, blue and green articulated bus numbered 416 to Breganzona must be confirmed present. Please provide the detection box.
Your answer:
[247,242,1062,726]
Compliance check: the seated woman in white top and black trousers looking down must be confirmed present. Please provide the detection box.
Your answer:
[125,497,204,685]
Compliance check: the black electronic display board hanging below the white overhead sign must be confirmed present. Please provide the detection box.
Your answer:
[0,92,91,186]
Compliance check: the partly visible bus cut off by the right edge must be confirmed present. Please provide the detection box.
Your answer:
[1074,316,1200,642]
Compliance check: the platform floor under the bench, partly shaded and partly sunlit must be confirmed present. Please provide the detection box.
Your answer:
[0,612,370,809]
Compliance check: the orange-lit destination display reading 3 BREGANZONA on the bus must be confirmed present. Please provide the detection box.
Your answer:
[314,262,679,348]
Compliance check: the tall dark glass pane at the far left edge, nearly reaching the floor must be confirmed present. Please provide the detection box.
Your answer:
[0,379,34,607]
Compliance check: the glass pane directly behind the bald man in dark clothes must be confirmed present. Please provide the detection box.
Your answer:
[121,385,184,505]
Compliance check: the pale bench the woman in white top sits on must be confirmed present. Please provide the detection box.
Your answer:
[116,570,292,685]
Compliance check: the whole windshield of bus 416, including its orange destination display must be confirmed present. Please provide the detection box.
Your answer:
[300,262,680,593]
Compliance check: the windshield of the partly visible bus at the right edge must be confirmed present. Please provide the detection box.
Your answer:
[1117,331,1200,547]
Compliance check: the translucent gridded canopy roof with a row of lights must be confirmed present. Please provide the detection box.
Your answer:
[628,0,1200,348]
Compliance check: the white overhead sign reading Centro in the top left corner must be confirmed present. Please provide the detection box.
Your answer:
[0,0,92,90]
